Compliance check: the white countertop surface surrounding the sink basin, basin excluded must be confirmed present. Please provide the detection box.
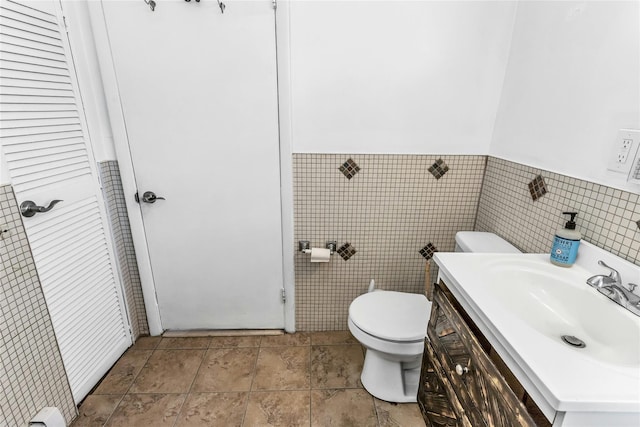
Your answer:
[434,248,640,416]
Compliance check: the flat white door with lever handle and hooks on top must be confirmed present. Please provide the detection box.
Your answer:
[103,0,284,329]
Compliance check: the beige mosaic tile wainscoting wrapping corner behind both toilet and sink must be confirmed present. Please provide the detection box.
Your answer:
[293,154,640,331]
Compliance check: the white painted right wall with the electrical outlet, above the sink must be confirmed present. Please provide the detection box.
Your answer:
[489,1,640,192]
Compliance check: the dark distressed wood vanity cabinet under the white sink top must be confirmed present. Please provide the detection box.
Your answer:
[418,282,550,427]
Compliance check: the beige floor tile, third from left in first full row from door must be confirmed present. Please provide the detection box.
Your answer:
[193,347,259,392]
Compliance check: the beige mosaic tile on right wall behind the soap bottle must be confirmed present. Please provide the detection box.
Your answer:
[476,157,640,264]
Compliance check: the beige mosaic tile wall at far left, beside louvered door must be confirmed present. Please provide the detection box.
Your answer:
[0,185,76,426]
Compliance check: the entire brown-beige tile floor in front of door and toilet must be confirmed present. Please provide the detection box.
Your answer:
[72,332,425,427]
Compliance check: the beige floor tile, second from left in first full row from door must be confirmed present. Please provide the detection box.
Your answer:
[129,350,205,393]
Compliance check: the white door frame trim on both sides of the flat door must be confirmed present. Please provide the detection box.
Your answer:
[87,0,295,335]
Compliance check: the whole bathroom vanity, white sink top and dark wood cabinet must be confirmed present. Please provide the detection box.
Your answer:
[418,242,640,427]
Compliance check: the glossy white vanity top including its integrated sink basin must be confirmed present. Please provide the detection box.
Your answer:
[434,242,640,418]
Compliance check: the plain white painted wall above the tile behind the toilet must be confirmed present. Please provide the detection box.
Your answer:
[290,1,516,154]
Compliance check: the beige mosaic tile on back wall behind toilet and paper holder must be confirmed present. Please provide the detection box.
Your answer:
[293,154,486,331]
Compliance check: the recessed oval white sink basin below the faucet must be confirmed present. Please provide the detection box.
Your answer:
[485,259,640,368]
